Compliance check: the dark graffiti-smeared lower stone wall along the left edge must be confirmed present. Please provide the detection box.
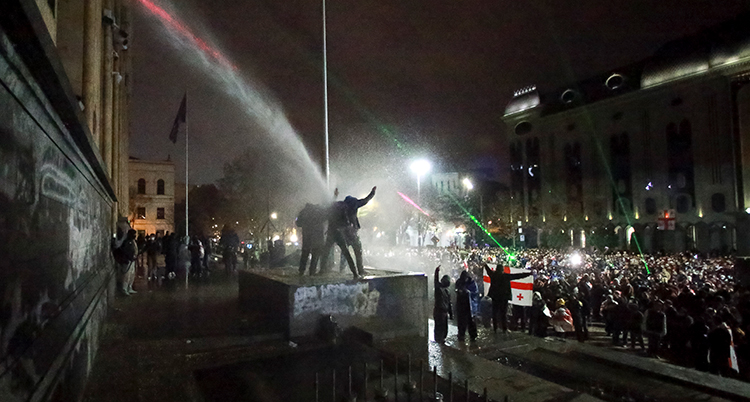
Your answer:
[0,11,114,402]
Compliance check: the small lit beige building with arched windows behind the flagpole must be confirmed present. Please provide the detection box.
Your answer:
[129,158,176,235]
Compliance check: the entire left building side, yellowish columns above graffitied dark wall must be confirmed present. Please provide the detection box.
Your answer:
[0,0,130,402]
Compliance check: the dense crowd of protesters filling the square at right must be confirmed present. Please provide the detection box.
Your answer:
[414,248,750,379]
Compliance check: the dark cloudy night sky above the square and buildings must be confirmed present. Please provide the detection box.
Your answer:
[130,0,750,188]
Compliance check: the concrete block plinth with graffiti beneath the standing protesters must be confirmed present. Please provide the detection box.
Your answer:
[239,268,428,341]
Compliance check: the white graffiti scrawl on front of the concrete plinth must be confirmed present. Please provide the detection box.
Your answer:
[294,283,380,317]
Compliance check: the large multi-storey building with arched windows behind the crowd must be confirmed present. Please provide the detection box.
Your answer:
[504,15,750,252]
